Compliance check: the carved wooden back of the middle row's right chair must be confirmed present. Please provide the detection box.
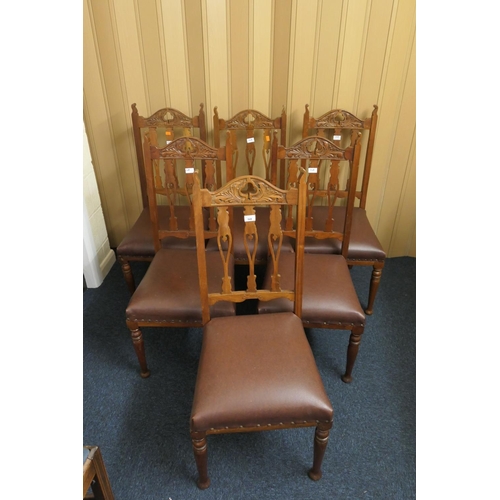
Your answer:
[278,133,361,257]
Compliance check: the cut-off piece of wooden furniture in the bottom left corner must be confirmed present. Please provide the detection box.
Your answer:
[82,446,115,500]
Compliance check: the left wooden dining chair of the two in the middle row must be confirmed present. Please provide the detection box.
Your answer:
[126,136,235,378]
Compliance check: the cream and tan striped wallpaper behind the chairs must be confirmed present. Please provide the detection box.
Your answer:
[83,0,416,257]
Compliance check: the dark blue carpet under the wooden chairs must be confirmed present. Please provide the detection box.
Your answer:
[82,257,416,500]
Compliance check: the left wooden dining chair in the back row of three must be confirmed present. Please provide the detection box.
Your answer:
[116,104,207,294]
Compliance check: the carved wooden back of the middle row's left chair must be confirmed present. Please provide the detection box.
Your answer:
[144,135,231,252]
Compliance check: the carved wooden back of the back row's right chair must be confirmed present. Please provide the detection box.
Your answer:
[302,104,378,209]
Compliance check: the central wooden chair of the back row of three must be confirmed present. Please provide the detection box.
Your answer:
[209,107,293,266]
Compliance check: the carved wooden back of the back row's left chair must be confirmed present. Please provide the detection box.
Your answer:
[132,103,207,208]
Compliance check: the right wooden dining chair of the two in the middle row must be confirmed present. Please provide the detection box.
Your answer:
[257,136,365,382]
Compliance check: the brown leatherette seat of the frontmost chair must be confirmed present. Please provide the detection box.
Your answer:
[191,314,333,432]
